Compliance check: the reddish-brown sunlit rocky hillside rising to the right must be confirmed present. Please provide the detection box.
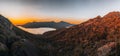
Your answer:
[44,12,120,56]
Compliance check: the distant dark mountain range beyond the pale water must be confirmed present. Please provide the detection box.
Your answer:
[22,21,74,29]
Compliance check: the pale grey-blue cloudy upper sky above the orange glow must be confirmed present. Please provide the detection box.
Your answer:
[0,0,120,18]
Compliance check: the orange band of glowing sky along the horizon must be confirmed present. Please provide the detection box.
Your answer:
[8,17,85,25]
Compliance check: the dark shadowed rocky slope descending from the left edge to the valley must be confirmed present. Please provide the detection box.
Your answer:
[0,15,52,56]
